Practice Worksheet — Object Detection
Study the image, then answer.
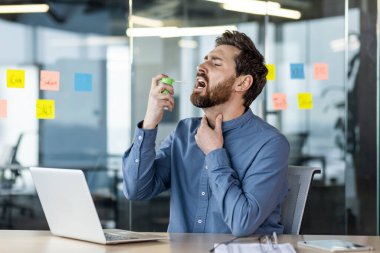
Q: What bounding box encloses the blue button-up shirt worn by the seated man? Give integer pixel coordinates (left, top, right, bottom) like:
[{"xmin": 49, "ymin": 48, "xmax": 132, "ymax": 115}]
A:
[{"xmin": 123, "ymin": 109, "xmax": 289, "ymax": 236}]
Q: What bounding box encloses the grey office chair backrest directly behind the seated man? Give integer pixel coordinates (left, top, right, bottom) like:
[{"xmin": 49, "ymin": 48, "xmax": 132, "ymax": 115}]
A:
[{"xmin": 281, "ymin": 165, "xmax": 321, "ymax": 235}]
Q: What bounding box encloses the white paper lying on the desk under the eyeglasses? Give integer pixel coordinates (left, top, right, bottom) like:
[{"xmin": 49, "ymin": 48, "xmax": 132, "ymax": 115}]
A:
[{"xmin": 215, "ymin": 243, "xmax": 296, "ymax": 253}]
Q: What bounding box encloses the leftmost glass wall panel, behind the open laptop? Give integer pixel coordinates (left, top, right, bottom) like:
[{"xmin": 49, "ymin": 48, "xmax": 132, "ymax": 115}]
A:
[{"xmin": 0, "ymin": 2, "xmax": 131, "ymax": 229}]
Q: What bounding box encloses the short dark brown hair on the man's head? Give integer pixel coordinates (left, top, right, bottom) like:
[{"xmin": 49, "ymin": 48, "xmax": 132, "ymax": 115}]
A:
[{"xmin": 215, "ymin": 31, "xmax": 268, "ymax": 107}]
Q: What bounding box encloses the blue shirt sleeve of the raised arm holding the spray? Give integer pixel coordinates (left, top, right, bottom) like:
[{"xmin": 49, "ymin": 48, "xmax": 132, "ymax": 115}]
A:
[{"xmin": 122, "ymin": 122, "xmax": 172, "ymax": 200}]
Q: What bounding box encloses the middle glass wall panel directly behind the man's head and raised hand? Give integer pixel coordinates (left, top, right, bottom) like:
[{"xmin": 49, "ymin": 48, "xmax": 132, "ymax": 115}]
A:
[{"xmin": 127, "ymin": 0, "xmax": 264, "ymax": 231}]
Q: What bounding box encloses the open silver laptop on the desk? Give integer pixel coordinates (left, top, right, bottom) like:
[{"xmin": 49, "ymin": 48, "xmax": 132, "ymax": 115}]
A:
[{"xmin": 30, "ymin": 167, "xmax": 167, "ymax": 244}]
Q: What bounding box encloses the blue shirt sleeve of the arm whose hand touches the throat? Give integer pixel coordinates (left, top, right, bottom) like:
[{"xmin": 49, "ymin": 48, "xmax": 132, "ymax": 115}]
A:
[{"xmin": 206, "ymin": 135, "xmax": 289, "ymax": 236}]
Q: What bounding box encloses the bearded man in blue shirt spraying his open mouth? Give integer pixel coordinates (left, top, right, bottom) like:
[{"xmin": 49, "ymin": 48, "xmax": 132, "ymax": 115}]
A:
[{"xmin": 123, "ymin": 31, "xmax": 289, "ymax": 236}]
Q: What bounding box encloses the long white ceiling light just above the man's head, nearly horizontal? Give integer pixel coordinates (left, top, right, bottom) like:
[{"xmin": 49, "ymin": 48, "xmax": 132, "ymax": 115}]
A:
[{"xmin": 127, "ymin": 25, "xmax": 237, "ymax": 38}]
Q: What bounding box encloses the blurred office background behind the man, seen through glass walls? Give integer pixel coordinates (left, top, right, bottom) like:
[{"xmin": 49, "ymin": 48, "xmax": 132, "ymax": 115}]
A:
[{"xmin": 0, "ymin": 0, "xmax": 380, "ymax": 235}]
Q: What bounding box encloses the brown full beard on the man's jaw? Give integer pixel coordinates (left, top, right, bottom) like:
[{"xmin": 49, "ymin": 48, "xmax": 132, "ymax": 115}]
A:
[{"xmin": 190, "ymin": 76, "xmax": 236, "ymax": 108}]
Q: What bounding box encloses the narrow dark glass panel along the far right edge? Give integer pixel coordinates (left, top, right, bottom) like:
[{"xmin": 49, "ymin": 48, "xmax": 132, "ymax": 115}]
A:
[{"xmin": 346, "ymin": 0, "xmax": 379, "ymax": 235}]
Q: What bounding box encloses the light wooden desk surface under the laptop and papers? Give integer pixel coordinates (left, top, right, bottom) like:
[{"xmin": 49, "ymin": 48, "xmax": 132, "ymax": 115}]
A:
[{"xmin": 0, "ymin": 230, "xmax": 380, "ymax": 253}]
